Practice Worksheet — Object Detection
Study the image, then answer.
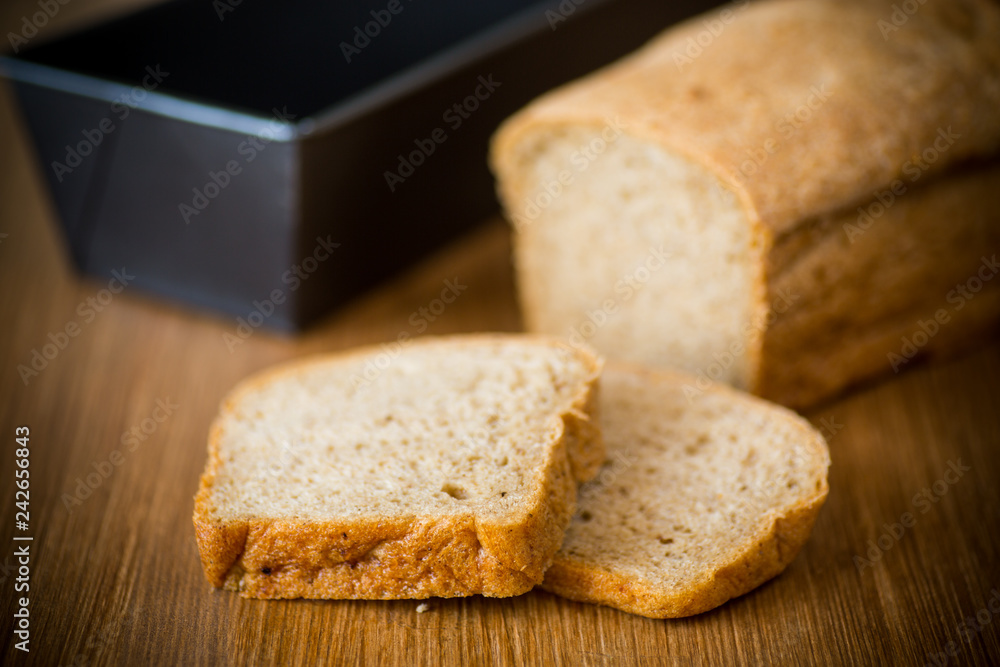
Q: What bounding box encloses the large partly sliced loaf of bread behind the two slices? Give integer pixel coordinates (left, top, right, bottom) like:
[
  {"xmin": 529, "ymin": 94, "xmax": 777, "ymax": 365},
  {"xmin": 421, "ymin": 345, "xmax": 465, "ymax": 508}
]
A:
[{"xmin": 491, "ymin": 0, "xmax": 1000, "ymax": 408}]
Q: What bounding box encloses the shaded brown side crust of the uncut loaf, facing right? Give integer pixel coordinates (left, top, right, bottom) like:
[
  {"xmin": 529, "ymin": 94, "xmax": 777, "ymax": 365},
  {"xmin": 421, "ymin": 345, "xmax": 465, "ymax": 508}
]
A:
[{"xmin": 753, "ymin": 161, "xmax": 1000, "ymax": 408}]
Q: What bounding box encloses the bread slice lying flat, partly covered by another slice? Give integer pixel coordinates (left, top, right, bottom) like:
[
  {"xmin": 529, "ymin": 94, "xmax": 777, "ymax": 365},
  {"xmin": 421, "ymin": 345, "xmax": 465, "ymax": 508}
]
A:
[{"xmin": 542, "ymin": 364, "xmax": 830, "ymax": 618}]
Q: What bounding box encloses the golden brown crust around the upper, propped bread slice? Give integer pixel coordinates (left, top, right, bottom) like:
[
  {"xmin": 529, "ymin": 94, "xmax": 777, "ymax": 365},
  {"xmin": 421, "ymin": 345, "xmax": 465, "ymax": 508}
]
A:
[{"xmin": 194, "ymin": 334, "xmax": 603, "ymax": 599}]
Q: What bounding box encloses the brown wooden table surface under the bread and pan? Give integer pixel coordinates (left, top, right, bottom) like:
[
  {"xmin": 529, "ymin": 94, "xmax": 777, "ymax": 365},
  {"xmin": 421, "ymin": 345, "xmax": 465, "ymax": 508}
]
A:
[{"xmin": 0, "ymin": 2, "xmax": 1000, "ymax": 665}]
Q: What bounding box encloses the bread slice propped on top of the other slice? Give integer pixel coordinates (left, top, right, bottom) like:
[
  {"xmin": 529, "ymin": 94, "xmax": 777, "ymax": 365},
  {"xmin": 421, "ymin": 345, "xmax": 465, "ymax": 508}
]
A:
[{"xmin": 194, "ymin": 335, "xmax": 603, "ymax": 599}]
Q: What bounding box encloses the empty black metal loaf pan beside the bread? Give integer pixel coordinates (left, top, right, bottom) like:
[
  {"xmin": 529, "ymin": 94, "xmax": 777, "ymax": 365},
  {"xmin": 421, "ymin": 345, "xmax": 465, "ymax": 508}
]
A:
[{"xmin": 0, "ymin": 0, "xmax": 715, "ymax": 330}]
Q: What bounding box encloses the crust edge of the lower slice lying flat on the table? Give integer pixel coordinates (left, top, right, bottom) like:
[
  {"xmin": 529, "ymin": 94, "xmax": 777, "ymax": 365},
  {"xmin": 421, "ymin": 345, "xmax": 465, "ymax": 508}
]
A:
[{"xmin": 541, "ymin": 363, "xmax": 830, "ymax": 618}]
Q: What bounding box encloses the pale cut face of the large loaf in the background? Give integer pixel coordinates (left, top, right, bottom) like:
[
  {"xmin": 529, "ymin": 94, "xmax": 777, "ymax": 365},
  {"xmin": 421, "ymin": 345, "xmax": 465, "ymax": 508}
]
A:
[{"xmin": 494, "ymin": 122, "xmax": 763, "ymax": 388}]
